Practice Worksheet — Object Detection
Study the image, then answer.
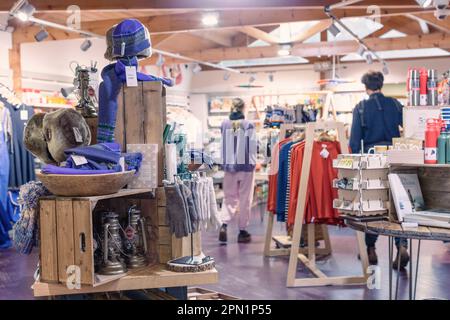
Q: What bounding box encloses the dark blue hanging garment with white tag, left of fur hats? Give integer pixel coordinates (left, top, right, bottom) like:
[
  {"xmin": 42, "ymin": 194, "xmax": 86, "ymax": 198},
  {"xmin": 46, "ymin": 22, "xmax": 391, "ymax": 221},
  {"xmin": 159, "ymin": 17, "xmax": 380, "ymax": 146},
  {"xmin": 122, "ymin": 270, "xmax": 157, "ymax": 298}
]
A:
[{"xmin": 0, "ymin": 99, "xmax": 36, "ymax": 188}]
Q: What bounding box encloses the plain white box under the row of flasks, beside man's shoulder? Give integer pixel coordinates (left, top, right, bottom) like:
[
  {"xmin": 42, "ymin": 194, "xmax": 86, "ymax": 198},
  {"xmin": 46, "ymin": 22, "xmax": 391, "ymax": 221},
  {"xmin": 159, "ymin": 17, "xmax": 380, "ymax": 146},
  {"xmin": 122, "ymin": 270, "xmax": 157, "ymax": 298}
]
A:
[{"xmin": 403, "ymin": 107, "xmax": 441, "ymax": 140}]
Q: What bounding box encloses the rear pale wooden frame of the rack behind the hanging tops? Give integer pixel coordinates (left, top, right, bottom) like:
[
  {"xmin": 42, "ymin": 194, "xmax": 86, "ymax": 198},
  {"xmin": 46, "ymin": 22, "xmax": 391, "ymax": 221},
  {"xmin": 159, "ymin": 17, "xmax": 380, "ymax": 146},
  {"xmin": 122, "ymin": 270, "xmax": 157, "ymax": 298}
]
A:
[{"xmin": 264, "ymin": 123, "xmax": 332, "ymax": 257}]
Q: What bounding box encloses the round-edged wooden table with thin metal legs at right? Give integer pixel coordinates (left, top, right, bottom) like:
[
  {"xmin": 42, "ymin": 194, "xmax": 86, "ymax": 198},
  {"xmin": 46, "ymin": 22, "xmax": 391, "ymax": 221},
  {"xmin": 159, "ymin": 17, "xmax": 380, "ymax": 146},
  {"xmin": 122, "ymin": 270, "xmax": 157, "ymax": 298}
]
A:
[{"xmin": 345, "ymin": 219, "xmax": 450, "ymax": 300}]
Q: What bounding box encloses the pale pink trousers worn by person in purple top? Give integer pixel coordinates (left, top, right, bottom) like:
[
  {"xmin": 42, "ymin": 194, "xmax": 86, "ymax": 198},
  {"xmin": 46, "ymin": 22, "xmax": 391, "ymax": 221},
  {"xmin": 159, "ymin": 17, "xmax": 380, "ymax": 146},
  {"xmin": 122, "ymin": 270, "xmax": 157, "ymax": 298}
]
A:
[{"xmin": 221, "ymin": 171, "xmax": 255, "ymax": 230}]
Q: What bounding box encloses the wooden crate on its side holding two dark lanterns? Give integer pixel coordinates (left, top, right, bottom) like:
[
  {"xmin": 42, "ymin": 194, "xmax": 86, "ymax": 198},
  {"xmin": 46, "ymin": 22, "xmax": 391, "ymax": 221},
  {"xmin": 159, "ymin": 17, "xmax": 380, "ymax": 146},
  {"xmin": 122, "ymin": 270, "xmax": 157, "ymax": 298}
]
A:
[{"xmin": 40, "ymin": 188, "xmax": 201, "ymax": 286}]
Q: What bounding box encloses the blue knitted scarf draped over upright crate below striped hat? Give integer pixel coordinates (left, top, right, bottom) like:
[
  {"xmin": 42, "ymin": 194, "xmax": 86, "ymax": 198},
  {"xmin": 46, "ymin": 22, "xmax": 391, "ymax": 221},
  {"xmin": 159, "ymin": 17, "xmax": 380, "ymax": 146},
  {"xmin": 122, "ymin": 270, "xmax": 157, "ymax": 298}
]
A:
[{"xmin": 97, "ymin": 57, "xmax": 173, "ymax": 143}]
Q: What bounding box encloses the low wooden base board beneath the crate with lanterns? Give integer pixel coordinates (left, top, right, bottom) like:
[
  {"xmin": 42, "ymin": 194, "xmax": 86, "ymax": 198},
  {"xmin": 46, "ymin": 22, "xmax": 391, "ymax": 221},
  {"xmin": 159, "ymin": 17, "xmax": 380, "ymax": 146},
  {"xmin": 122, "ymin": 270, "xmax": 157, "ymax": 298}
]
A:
[{"xmin": 32, "ymin": 264, "xmax": 219, "ymax": 297}]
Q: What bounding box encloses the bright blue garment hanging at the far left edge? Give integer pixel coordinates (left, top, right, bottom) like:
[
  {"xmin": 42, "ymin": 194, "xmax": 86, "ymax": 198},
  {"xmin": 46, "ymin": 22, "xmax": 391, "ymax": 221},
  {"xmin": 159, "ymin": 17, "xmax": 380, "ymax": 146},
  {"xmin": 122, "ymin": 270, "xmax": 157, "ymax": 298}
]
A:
[{"xmin": 0, "ymin": 107, "xmax": 12, "ymax": 248}]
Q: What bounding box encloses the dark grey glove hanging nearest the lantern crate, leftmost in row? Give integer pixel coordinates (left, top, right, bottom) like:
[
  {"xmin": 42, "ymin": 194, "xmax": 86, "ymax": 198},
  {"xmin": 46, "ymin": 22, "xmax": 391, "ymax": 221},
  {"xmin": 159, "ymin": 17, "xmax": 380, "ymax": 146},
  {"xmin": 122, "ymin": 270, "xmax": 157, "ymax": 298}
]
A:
[{"xmin": 164, "ymin": 184, "xmax": 189, "ymax": 238}]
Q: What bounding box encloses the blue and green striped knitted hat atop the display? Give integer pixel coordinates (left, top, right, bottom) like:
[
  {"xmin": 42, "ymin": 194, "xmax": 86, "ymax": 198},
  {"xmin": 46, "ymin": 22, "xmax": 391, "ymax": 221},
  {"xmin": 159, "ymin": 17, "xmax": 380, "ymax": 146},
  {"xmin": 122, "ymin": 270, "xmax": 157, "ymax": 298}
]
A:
[{"xmin": 112, "ymin": 19, "xmax": 152, "ymax": 59}]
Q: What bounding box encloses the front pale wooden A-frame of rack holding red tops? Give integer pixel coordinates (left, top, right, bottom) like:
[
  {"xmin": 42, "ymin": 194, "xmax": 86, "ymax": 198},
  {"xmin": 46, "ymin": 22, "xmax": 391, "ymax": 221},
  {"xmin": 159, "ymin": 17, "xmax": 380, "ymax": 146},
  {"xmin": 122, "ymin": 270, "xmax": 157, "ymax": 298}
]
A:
[{"xmin": 286, "ymin": 121, "xmax": 368, "ymax": 287}]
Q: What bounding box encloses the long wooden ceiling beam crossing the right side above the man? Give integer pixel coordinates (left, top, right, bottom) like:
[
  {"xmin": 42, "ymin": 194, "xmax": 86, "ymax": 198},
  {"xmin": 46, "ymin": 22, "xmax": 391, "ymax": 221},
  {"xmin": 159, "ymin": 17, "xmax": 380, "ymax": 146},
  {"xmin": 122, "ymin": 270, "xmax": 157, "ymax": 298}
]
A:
[{"xmin": 163, "ymin": 33, "xmax": 450, "ymax": 62}]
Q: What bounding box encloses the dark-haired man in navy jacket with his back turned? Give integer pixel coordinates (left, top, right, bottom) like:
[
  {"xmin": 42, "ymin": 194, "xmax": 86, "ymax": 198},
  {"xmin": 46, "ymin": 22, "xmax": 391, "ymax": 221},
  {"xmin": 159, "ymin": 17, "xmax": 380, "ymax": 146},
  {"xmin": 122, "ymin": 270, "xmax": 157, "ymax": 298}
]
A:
[{"xmin": 350, "ymin": 71, "xmax": 409, "ymax": 269}]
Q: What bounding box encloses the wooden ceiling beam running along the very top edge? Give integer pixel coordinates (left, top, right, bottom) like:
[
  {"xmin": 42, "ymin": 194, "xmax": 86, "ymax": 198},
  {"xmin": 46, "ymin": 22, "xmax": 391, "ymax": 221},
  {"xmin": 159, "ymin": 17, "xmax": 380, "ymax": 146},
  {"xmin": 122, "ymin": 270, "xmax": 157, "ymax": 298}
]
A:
[{"xmin": 0, "ymin": 0, "xmax": 417, "ymax": 11}]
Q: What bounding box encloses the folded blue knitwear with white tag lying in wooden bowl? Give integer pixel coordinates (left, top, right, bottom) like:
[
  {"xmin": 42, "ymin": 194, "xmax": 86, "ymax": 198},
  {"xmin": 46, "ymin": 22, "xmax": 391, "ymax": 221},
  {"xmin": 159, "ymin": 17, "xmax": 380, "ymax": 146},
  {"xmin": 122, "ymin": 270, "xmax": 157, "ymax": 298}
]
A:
[{"xmin": 42, "ymin": 142, "xmax": 142, "ymax": 174}]
